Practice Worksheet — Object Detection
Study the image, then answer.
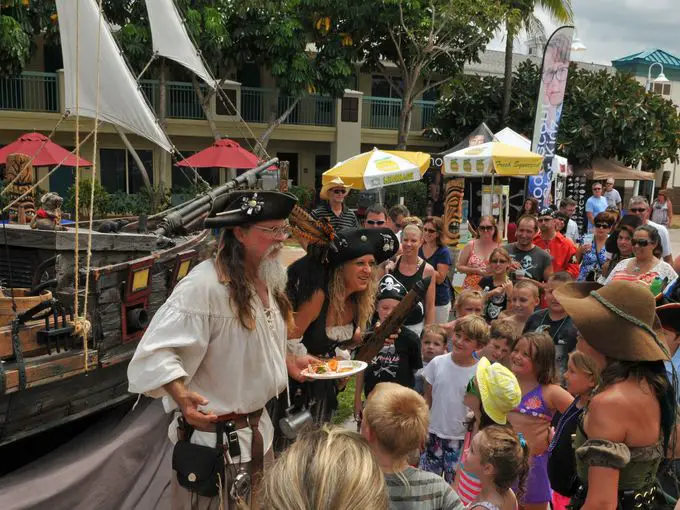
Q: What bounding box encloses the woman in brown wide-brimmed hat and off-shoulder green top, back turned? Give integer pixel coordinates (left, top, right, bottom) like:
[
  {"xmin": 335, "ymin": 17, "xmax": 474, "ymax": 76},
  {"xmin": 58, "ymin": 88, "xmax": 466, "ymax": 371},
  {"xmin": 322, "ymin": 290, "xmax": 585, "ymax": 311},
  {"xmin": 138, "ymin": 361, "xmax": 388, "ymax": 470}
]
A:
[{"xmin": 554, "ymin": 280, "xmax": 677, "ymax": 510}]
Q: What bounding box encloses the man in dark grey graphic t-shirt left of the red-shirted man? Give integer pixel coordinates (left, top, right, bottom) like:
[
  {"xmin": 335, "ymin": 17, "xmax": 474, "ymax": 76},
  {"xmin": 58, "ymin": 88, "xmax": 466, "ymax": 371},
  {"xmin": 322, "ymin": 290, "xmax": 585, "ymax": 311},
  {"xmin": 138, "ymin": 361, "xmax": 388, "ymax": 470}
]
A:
[{"xmin": 503, "ymin": 216, "xmax": 553, "ymax": 283}]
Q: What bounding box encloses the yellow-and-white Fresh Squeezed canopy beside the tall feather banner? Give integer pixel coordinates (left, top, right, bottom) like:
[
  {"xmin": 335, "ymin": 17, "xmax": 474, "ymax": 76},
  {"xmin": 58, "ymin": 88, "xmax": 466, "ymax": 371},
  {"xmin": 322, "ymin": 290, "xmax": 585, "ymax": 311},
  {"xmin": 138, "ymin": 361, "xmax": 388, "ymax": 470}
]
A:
[{"xmin": 442, "ymin": 142, "xmax": 543, "ymax": 177}]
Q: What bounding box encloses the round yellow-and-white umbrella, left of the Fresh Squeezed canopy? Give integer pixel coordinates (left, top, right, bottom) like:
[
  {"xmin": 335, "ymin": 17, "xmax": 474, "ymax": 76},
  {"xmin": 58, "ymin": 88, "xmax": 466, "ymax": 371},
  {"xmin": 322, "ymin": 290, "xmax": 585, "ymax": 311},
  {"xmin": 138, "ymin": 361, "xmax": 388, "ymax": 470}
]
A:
[{"xmin": 322, "ymin": 148, "xmax": 430, "ymax": 190}]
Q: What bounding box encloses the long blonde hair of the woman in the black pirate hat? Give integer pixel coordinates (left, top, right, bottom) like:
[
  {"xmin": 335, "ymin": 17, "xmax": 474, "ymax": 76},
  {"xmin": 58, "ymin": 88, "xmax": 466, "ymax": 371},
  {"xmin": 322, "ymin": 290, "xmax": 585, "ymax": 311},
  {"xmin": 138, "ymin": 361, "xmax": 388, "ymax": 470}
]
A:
[{"xmin": 328, "ymin": 260, "xmax": 378, "ymax": 331}]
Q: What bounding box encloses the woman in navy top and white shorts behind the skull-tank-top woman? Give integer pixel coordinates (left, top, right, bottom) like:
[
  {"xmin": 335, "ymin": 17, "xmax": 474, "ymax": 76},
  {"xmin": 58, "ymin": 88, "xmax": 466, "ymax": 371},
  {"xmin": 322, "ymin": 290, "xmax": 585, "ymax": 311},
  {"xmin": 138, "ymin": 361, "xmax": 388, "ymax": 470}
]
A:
[{"xmin": 418, "ymin": 216, "xmax": 451, "ymax": 324}]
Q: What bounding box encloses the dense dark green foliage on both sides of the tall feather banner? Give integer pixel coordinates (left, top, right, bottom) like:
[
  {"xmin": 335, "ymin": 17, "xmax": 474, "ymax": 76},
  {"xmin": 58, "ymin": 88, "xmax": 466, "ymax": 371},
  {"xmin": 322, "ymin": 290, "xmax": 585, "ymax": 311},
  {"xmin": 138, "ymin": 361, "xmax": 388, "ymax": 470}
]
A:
[{"xmin": 433, "ymin": 61, "xmax": 680, "ymax": 170}]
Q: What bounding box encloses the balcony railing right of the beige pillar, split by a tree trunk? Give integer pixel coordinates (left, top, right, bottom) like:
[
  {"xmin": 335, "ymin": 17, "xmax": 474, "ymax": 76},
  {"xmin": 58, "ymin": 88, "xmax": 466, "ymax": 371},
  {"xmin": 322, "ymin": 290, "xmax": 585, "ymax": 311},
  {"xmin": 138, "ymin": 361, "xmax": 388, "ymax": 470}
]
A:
[{"xmin": 361, "ymin": 96, "xmax": 437, "ymax": 131}]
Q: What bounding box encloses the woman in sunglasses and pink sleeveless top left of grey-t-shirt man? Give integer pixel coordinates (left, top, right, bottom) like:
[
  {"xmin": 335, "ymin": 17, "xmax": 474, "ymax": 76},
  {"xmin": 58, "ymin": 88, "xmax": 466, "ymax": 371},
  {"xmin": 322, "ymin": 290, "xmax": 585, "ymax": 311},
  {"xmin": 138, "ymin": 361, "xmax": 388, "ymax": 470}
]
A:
[{"xmin": 456, "ymin": 216, "xmax": 501, "ymax": 290}]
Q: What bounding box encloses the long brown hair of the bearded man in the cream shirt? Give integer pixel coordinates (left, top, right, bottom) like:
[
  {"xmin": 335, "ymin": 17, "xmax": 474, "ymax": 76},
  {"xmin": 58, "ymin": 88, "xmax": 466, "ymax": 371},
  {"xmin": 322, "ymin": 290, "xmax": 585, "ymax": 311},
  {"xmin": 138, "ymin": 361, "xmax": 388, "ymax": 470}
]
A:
[{"xmin": 215, "ymin": 229, "xmax": 293, "ymax": 331}]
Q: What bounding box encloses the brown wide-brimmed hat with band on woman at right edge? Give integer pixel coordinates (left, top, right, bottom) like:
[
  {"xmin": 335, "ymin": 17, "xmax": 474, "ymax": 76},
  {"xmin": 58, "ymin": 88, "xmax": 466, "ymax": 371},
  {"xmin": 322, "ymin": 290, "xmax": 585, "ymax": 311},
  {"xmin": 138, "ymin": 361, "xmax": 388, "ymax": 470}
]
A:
[{"xmin": 553, "ymin": 280, "xmax": 670, "ymax": 361}]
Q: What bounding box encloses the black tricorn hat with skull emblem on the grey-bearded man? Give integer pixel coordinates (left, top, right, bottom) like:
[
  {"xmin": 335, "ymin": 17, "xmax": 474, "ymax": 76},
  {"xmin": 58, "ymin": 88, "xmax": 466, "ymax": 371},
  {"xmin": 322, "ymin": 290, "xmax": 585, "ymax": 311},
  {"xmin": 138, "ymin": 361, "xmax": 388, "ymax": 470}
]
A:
[{"xmin": 204, "ymin": 191, "xmax": 297, "ymax": 228}]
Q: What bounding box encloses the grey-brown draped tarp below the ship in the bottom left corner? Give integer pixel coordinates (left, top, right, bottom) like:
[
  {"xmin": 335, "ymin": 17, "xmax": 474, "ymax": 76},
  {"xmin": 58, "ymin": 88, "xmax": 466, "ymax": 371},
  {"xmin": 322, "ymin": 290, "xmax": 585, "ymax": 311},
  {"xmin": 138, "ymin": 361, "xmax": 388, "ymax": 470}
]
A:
[{"xmin": 0, "ymin": 398, "xmax": 172, "ymax": 510}]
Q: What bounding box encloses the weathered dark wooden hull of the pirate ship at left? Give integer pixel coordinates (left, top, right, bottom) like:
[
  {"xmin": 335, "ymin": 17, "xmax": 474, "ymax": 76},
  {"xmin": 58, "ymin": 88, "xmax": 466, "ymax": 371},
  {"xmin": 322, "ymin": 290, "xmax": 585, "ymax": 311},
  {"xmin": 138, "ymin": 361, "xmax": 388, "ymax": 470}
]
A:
[{"xmin": 0, "ymin": 225, "xmax": 210, "ymax": 446}]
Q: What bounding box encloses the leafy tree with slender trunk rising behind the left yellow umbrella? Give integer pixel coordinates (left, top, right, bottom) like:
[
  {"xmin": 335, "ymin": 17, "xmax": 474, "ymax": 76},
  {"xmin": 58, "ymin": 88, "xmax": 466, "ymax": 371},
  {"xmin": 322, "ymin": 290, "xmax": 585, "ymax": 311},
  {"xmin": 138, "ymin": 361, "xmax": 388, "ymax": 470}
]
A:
[{"xmin": 310, "ymin": 0, "xmax": 502, "ymax": 148}]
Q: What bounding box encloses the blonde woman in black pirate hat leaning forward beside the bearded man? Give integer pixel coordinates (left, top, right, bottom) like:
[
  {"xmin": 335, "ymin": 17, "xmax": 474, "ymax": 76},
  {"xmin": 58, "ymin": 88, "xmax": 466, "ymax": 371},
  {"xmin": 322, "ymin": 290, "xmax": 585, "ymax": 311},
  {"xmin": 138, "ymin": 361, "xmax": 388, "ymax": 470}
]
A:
[{"xmin": 278, "ymin": 216, "xmax": 399, "ymax": 442}]
